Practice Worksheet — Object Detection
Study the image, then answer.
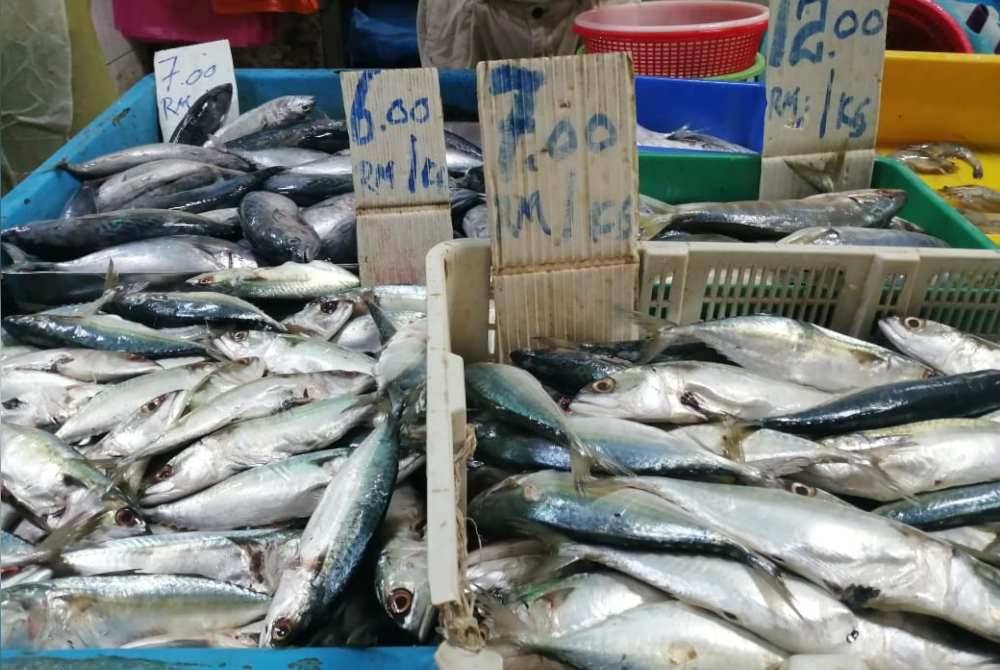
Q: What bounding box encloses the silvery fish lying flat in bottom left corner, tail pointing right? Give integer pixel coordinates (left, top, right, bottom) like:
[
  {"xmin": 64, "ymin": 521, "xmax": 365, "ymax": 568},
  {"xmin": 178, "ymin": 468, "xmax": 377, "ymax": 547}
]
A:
[{"xmin": 0, "ymin": 575, "xmax": 270, "ymax": 651}]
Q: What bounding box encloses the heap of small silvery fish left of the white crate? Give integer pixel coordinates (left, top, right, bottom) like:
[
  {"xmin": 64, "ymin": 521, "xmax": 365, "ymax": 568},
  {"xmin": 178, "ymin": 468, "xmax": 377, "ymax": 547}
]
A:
[{"xmin": 0, "ymin": 268, "xmax": 433, "ymax": 650}]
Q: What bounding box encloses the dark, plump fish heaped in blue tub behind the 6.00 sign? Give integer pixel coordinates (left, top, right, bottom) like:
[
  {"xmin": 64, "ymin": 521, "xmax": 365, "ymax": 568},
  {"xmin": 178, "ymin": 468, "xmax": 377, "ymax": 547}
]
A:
[{"xmin": 0, "ymin": 84, "xmax": 484, "ymax": 275}]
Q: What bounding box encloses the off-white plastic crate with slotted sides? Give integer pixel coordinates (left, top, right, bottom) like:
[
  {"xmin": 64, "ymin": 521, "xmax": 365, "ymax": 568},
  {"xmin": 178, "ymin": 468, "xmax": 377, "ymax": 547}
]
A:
[{"xmin": 427, "ymin": 240, "xmax": 1000, "ymax": 646}]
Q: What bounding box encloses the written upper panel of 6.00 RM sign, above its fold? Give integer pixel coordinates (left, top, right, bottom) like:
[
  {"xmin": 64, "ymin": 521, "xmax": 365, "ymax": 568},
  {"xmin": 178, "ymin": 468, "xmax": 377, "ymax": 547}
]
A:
[{"xmin": 341, "ymin": 69, "xmax": 448, "ymax": 206}]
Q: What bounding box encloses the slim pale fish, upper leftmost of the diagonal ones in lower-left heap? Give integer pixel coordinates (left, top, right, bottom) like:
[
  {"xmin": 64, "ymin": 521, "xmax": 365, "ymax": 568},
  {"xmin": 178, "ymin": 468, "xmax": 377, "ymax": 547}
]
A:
[{"xmin": 56, "ymin": 363, "xmax": 217, "ymax": 442}]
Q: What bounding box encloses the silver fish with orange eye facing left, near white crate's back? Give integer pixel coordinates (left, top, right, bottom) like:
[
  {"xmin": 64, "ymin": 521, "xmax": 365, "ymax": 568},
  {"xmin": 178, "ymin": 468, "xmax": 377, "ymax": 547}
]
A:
[{"xmin": 570, "ymin": 362, "xmax": 834, "ymax": 422}]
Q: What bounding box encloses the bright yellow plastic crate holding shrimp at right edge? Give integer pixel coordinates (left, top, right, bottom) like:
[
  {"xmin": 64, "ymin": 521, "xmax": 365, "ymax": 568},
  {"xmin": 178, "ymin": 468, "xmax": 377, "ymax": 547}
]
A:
[{"xmin": 878, "ymin": 51, "xmax": 1000, "ymax": 243}]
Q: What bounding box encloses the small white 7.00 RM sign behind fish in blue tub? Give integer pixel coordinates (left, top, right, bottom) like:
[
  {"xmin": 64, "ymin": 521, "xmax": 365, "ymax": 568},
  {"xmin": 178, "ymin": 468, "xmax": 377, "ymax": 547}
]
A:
[{"xmin": 153, "ymin": 40, "xmax": 240, "ymax": 141}]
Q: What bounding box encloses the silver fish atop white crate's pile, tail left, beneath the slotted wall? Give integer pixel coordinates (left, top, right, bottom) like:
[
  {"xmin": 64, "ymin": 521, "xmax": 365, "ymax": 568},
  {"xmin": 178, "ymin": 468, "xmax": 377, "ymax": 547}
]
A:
[{"xmin": 641, "ymin": 315, "xmax": 934, "ymax": 393}]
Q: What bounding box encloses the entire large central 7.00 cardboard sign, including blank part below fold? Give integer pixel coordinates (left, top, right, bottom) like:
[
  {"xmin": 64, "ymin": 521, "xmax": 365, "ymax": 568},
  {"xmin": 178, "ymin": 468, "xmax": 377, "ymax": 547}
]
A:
[{"xmin": 478, "ymin": 54, "xmax": 638, "ymax": 359}]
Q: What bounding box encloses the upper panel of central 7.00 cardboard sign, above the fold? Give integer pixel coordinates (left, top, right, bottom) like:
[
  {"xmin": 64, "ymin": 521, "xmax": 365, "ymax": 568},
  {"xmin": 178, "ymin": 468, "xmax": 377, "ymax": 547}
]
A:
[{"xmin": 479, "ymin": 56, "xmax": 636, "ymax": 267}]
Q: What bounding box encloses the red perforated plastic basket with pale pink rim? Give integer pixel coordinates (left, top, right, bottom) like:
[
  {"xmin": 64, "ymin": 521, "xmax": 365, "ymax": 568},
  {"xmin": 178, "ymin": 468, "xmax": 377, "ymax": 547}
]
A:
[{"xmin": 573, "ymin": 0, "xmax": 769, "ymax": 78}]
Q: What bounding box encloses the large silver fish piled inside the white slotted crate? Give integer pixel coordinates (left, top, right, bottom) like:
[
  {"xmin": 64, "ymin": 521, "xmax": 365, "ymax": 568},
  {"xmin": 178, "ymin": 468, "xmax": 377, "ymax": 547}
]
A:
[{"xmin": 458, "ymin": 315, "xmax": 1000, "ymax": 670}]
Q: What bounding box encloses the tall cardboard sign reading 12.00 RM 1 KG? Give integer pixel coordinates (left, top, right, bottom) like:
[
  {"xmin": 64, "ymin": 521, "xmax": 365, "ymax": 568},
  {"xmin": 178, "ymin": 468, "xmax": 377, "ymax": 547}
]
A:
[{"xmin": 760, "ymin": 0, "xmax": 889, "ymax": 198}]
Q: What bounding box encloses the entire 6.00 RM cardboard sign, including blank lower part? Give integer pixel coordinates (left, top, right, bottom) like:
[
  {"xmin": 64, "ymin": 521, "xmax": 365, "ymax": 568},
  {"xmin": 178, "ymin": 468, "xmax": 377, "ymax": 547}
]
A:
[{"xmin": 340, "ymin": 68, "xmax": 452, "ymax": 286}]
